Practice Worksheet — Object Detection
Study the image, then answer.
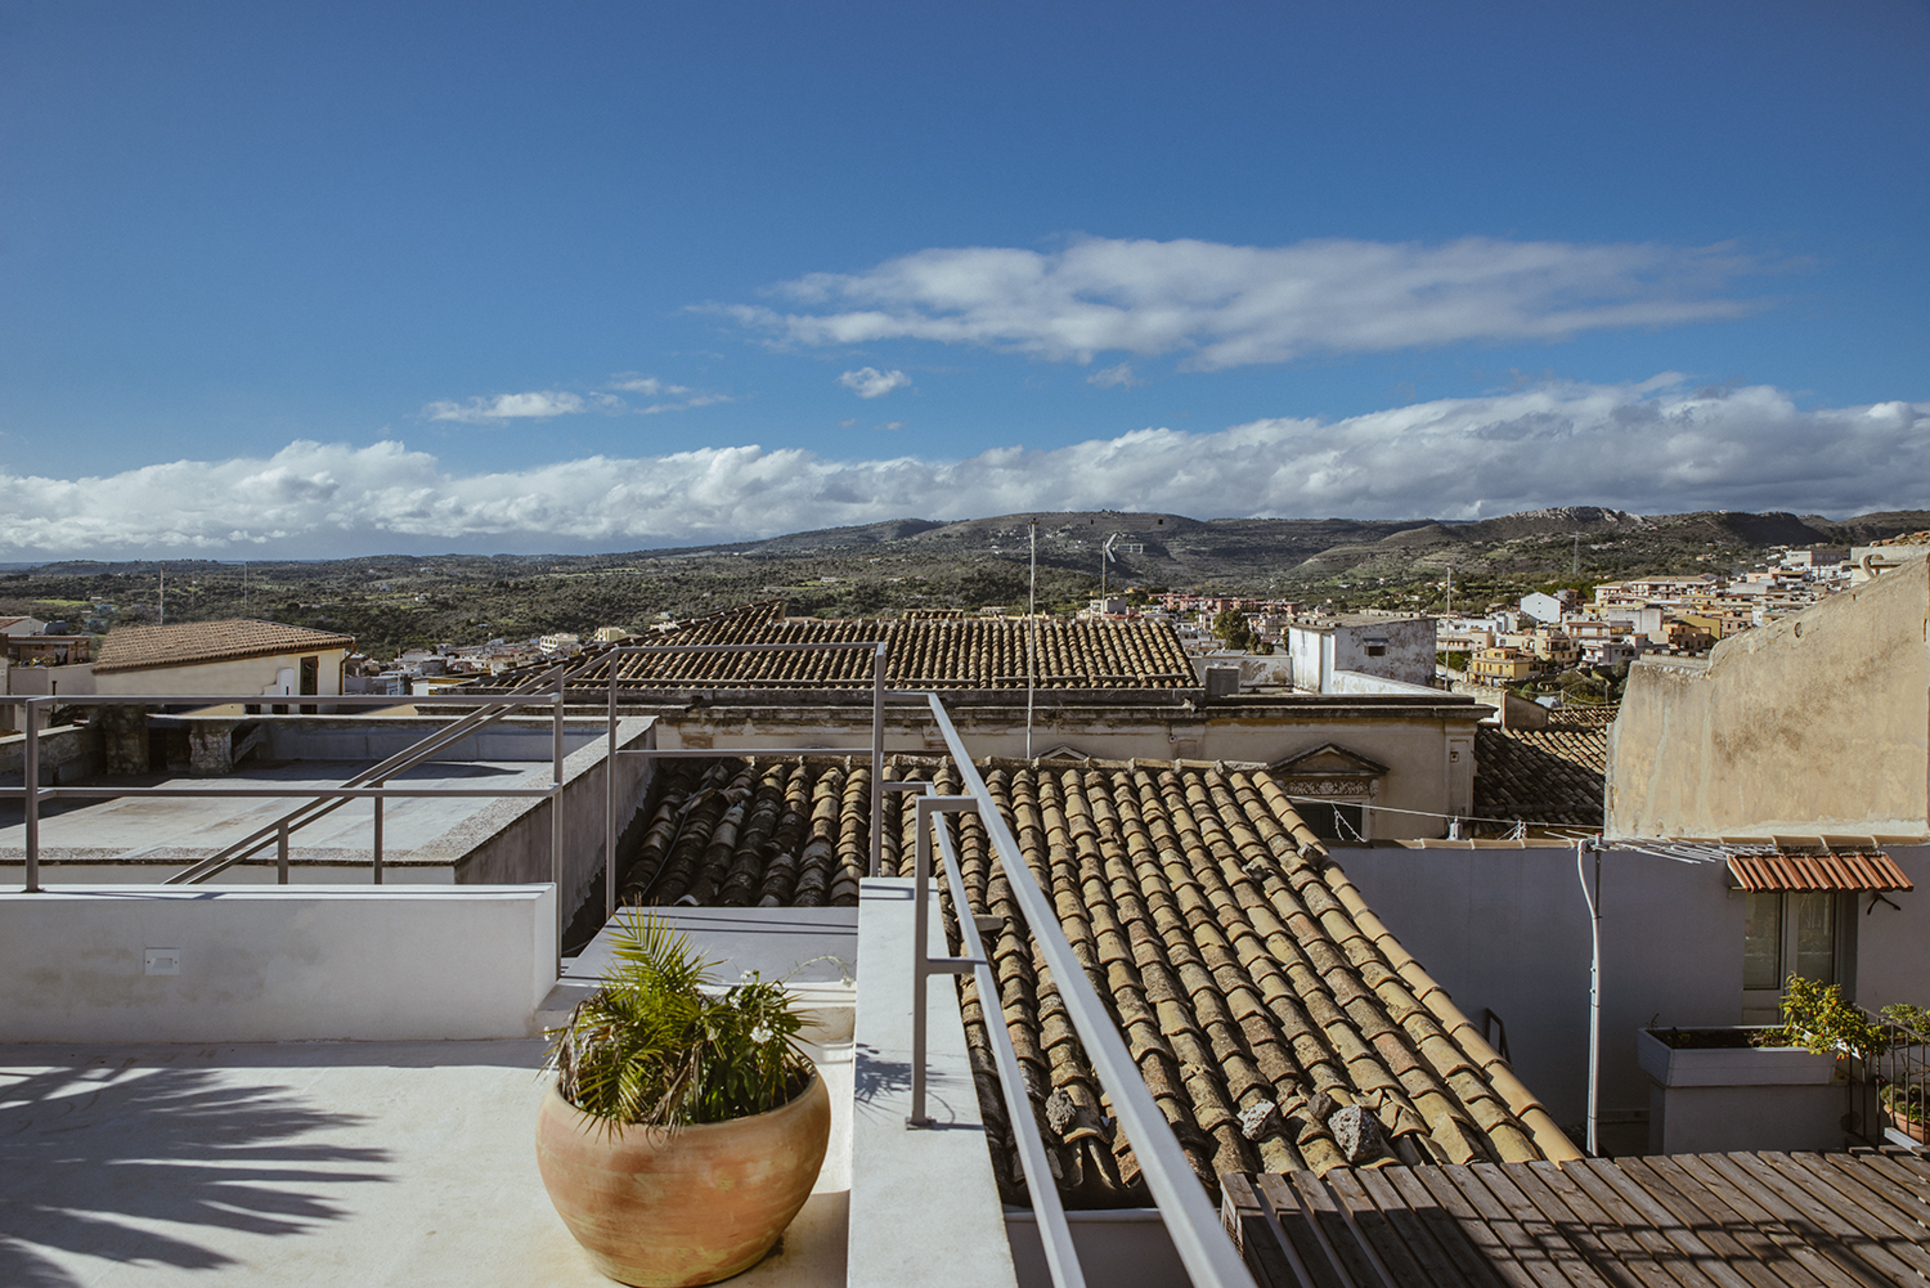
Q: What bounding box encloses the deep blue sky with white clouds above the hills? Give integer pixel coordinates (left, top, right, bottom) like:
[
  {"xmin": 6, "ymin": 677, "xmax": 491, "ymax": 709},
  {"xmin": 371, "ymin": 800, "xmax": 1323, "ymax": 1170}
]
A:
[{"xmin": 0, "ymin": 0, "xmax": 1930, "ymax": 558}]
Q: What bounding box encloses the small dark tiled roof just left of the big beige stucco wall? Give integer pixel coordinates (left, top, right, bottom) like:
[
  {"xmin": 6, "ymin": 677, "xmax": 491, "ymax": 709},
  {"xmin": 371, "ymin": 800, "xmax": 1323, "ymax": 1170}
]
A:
[{"xmin": 1475, "ymin": 709, "xmax": 1613, "ymax": 830}]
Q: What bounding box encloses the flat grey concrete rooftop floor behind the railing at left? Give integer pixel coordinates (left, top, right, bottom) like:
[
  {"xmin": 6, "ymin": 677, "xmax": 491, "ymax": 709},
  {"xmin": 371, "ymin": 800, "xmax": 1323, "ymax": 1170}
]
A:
[{"xmin": 0, "ymin": 761, "xmax": 550, "ymax": 865}]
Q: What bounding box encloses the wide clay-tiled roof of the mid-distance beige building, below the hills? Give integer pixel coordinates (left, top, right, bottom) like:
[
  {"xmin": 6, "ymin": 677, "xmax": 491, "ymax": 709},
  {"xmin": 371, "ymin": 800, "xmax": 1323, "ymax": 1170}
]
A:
[{"xmin": 470, "ymin": 601, "xmax": 1199, "ymax": 691}]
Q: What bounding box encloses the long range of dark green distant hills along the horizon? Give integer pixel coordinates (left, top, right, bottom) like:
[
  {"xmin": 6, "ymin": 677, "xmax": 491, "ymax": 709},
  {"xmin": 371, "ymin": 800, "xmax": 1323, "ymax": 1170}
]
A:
[{"xmin": 0, "ymin": 506, "xmax": 1930, "ymax": 657}]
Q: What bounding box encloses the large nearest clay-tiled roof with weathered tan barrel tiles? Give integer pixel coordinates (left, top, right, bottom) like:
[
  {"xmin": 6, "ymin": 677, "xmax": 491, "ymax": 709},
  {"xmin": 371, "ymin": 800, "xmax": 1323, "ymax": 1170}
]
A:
[{"xmin": 621, "ymin": 757, "xmax": 1573, "ymax": 1207}]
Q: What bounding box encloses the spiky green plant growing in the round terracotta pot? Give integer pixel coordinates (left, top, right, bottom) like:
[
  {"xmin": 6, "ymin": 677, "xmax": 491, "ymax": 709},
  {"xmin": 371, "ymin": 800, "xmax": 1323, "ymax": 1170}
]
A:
[{"xmin": 546, "ymin": 908, "xmax": 811, "ymax": 1132}]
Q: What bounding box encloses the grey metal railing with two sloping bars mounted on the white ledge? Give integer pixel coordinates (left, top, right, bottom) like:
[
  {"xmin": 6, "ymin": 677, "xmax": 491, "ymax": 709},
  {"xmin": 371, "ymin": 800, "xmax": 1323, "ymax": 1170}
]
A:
[{"xmin": 910, "ymin": 693, "xmax": 1253, "ymax": 1288}]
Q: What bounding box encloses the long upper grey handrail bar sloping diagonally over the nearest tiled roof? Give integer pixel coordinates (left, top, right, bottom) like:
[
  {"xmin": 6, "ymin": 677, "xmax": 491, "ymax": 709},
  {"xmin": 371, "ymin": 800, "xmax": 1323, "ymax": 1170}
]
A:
[{"xmin": 911, "ymin": 693, "xmax": 1255, "ymax": 1288}]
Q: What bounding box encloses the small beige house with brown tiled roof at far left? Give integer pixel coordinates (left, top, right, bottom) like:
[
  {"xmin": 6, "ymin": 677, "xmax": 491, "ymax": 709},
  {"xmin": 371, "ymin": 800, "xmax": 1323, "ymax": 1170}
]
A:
[{"xmin": 95, "ymin": 618, "xmax": 355, "ymax": 697}]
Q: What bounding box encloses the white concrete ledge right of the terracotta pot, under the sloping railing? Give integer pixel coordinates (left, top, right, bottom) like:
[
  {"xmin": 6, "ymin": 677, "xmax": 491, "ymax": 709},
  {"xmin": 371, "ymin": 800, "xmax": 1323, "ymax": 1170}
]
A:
[{"xmin": 845, "ymin": 879, "xmax": 1019, "ymax": 1288}]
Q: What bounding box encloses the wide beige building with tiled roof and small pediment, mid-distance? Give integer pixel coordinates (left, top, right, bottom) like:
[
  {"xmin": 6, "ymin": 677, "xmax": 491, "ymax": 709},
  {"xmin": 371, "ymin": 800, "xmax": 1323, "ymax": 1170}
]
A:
[{"xmin": 465, "ymin": 601, "xmax": 1490, "ymax": 840}]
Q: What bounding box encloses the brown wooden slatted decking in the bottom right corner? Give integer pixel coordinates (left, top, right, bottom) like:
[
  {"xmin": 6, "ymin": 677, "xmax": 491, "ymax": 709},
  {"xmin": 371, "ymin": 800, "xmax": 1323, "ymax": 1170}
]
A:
[{"xmin": 1222, "ymin": 1151, "xmax": 1930, "ymax": 1288}]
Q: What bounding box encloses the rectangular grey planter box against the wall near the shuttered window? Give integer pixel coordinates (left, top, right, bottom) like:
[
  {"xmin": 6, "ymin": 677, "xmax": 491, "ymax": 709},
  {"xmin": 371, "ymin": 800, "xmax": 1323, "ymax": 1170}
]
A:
[{"xmin": 1635, "ymin": 1027, "xmax": 1849, "ymax": 1155}]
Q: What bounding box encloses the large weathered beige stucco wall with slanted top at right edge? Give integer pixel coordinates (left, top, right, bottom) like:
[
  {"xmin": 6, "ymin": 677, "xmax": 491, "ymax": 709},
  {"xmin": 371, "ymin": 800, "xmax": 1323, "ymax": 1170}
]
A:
[{"xmin": 1608, "ymin": 560, "xmax": 1930, "ymax": 838}]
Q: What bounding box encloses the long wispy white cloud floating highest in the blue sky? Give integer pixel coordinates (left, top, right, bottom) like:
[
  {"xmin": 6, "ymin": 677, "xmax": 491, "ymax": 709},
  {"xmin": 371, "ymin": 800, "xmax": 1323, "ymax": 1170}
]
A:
[{"xmin": 720, "ymin": 238, "xmax": 1760, "ymax": 371}]
